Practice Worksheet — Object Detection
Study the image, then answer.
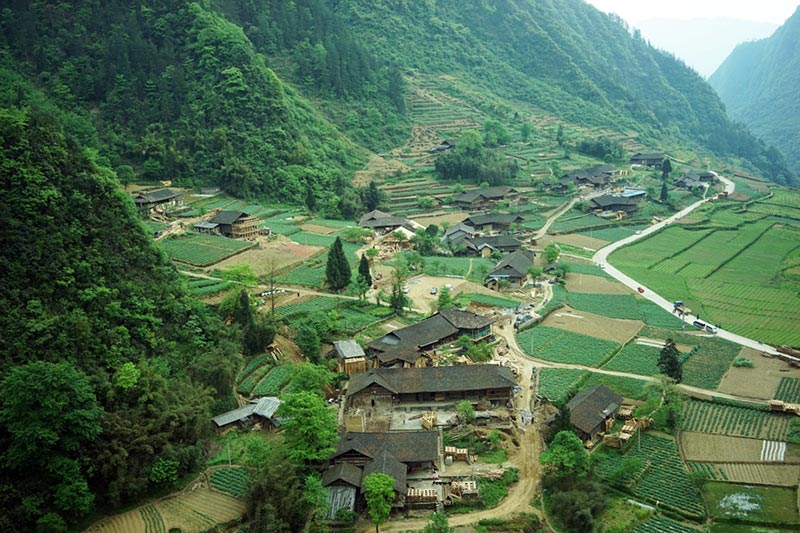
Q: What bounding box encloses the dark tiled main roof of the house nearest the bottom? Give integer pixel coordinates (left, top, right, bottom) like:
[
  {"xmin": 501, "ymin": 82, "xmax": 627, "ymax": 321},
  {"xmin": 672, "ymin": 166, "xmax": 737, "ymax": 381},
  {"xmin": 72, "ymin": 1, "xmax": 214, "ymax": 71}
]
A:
[{"xmin": 333, "ymin": 431, "xmax": 439, "ymax": 463}]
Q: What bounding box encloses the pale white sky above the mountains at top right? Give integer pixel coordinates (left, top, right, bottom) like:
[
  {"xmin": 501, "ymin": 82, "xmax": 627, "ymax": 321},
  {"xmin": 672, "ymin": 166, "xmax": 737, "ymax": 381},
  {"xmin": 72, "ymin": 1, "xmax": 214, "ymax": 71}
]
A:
[{"xmin": 586, "ymin": 0, "xmax": 800, "ymax": 25}]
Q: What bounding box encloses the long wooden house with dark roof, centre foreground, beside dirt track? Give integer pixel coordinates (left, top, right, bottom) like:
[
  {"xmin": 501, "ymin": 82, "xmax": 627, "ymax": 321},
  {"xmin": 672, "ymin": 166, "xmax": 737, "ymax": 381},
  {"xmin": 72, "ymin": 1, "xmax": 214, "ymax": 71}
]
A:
[{"xmin": 345, "ymin": 365, "xmax": 516, "ymax": 408}]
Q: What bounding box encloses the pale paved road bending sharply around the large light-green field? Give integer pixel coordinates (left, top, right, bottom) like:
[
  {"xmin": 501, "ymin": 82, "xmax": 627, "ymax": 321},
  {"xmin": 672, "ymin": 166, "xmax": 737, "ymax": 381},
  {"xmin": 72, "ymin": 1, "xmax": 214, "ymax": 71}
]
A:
[{"xmin": 592, "ymin": 176, "xmax": 779, "ymax": 355}]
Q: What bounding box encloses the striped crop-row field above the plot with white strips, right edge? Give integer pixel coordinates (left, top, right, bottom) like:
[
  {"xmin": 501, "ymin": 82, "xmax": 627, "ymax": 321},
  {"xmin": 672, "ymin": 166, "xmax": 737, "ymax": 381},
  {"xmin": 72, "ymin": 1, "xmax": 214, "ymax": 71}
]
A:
[{"xmin": 679, "ymin": 400, "xmax": 792, "ymax": 441}]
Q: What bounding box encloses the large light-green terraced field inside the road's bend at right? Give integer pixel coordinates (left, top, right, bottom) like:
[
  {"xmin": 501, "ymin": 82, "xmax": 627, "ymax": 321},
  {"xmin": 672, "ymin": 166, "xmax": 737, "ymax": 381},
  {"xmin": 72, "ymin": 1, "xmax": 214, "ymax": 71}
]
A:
[{"xmin": 609, "ymin": 197, "xmax": 800, "ymax": 345}]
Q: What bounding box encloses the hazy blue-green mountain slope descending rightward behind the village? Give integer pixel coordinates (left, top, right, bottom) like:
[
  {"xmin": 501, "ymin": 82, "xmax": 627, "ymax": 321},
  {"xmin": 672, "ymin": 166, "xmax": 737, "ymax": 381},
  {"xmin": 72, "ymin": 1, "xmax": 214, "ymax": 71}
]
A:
[{"xmin": 335, "ymin": 0, "xmax": 793, "ymax": 183}]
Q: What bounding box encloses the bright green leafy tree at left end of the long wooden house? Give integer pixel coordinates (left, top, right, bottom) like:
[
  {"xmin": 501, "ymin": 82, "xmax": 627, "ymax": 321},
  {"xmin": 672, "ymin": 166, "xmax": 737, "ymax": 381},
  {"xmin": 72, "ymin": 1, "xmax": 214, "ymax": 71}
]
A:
[{"xmin": 278, "ymin": 391, "xmax": 339, "ymax": 465}]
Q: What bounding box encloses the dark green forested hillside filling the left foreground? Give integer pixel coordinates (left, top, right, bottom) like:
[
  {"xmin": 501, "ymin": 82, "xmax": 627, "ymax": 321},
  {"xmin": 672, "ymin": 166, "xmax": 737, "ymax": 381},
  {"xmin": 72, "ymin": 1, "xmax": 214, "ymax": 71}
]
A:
[{"xmin": 0, "ymin": 70, "xmax": 241, "ymax": 531}]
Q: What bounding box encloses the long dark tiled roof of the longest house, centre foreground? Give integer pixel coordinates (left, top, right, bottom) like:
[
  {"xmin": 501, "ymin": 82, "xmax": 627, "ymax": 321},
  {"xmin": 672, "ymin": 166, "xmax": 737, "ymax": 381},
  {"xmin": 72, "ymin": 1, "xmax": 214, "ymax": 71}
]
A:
[{"xmin": 347, "ymin": 365, "xmax": 516, "ymax": 396}]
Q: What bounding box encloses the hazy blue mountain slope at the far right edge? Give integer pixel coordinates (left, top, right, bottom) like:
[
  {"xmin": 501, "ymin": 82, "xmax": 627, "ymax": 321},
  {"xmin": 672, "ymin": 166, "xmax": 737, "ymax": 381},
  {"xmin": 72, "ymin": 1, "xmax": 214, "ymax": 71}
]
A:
[{"xmin": 708, "ymin": 8, "xmax": 800, "ymax": 178}]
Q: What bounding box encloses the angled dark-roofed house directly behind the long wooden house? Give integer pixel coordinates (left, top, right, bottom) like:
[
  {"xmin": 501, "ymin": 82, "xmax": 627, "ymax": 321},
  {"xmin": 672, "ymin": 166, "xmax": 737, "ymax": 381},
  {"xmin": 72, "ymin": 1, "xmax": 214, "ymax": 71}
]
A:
[{"xmin": 367, "ymin": 307, "xmax": 495, "ymax": 367}]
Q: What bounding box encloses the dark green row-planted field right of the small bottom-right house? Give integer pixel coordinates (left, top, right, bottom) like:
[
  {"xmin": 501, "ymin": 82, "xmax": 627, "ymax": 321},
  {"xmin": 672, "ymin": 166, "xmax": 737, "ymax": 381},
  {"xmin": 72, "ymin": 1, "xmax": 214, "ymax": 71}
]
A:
[{"xmin": 597, "ymin": 433, "xmax": 706, "ymax": 518}]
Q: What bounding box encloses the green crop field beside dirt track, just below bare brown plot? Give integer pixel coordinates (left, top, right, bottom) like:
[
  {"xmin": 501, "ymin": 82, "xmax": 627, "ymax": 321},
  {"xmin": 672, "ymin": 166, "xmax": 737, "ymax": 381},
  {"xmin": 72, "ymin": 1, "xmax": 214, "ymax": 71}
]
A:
[{"xmin": 517, "ymin": 326, "xmax": 619, "ymax": 366}]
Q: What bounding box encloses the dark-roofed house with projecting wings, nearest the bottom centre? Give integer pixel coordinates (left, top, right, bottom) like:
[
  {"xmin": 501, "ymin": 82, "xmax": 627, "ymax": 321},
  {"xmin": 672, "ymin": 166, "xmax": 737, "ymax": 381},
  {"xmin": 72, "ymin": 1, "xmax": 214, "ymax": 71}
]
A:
[{"xmin": 322, "ymin": 431, "xmax": 443, "ymax": 520}]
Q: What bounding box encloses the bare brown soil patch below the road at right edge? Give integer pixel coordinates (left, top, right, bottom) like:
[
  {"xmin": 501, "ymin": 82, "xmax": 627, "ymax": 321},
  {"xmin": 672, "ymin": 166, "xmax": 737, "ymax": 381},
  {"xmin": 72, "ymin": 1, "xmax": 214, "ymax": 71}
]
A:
[{"xmin": 719, "ymin": 348, "xmax": 800, "ymax": 400}]
